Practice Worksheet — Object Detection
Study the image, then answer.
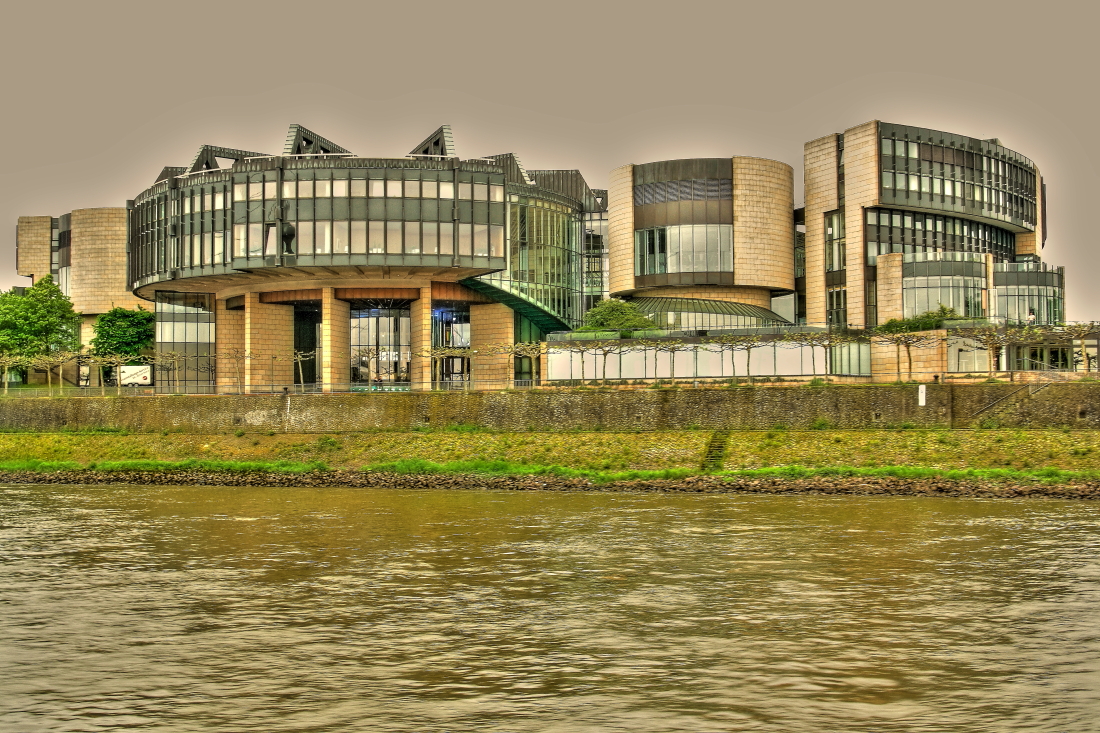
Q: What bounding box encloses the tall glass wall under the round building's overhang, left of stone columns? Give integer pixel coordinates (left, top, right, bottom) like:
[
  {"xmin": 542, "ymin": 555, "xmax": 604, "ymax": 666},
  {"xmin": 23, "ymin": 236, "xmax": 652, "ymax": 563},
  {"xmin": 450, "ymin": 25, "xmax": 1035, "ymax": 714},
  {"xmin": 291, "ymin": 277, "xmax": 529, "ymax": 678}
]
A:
[{"xmin": 154, "ymin": 291, "xmax": 216, "ymax": 393}]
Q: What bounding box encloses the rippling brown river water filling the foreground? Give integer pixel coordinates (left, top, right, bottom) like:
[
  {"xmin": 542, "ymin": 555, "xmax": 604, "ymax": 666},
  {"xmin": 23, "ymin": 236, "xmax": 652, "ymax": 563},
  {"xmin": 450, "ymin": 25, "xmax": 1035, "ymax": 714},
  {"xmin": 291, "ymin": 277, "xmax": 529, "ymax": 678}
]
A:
[{"xmin": 0, "ymin": 485, "xmax": 1100, "ymax": 733}]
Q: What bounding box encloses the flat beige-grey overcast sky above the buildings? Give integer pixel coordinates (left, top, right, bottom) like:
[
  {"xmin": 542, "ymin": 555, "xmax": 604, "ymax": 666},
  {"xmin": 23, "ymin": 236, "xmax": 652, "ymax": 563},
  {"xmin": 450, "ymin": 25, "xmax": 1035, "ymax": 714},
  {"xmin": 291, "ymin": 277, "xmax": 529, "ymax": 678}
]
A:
[{"xmin": 0, "ymin": 0, "xmax": 1100, "ymax": 320}]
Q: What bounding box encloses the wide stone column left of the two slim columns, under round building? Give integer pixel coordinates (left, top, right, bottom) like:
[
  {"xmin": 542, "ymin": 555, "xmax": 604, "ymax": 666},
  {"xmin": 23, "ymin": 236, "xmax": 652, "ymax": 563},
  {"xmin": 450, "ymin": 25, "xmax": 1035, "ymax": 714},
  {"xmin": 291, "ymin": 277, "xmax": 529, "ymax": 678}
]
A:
[{"xmin": 244, "ymin": 293, "xmax": 294, "ymax": 392}]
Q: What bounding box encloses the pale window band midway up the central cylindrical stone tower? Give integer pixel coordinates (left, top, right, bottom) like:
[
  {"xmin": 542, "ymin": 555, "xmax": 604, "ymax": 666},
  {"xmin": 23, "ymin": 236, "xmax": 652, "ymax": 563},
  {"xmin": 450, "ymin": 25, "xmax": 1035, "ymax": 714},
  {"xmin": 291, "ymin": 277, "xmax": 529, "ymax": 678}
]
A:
[{"xmin": 634, "ymin": 225, "xmax": 734, "ymax": 275}]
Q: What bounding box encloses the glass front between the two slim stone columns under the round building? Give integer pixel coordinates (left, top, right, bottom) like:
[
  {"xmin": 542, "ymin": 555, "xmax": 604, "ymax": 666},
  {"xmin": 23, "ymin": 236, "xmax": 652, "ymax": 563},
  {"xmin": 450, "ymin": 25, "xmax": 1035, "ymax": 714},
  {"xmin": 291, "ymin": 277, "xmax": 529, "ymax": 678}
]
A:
[{"xmin": 351, "ymin": 299, "xmax": 413, "ymax": 387}]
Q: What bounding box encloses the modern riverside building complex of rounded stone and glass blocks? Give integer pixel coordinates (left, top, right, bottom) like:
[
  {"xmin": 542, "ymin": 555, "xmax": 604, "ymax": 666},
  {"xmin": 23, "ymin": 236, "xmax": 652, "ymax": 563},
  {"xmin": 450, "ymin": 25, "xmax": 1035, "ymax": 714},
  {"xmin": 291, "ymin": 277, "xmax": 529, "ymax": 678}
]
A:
[{"xmin": 17, "ymin": 121, "xmax": 1064, "ymax": 389}]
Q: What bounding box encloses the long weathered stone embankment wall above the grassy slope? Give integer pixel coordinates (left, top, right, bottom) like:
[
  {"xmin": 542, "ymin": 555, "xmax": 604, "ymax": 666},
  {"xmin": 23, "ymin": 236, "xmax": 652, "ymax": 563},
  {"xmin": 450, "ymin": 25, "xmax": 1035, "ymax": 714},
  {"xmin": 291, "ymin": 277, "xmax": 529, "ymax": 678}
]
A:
[{"xmin": 0, "ymin": 383, "xmax": 1100, "ymax": 433}]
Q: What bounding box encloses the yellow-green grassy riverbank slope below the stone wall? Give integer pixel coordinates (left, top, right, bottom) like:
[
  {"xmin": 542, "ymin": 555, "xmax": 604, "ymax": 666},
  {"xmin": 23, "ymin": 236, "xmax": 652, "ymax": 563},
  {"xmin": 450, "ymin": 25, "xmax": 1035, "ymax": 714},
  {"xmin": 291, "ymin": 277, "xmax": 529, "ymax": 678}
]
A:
[{"xmin": 0, "ymin": 429, "xmax": 1100, "ymax": 478}]
